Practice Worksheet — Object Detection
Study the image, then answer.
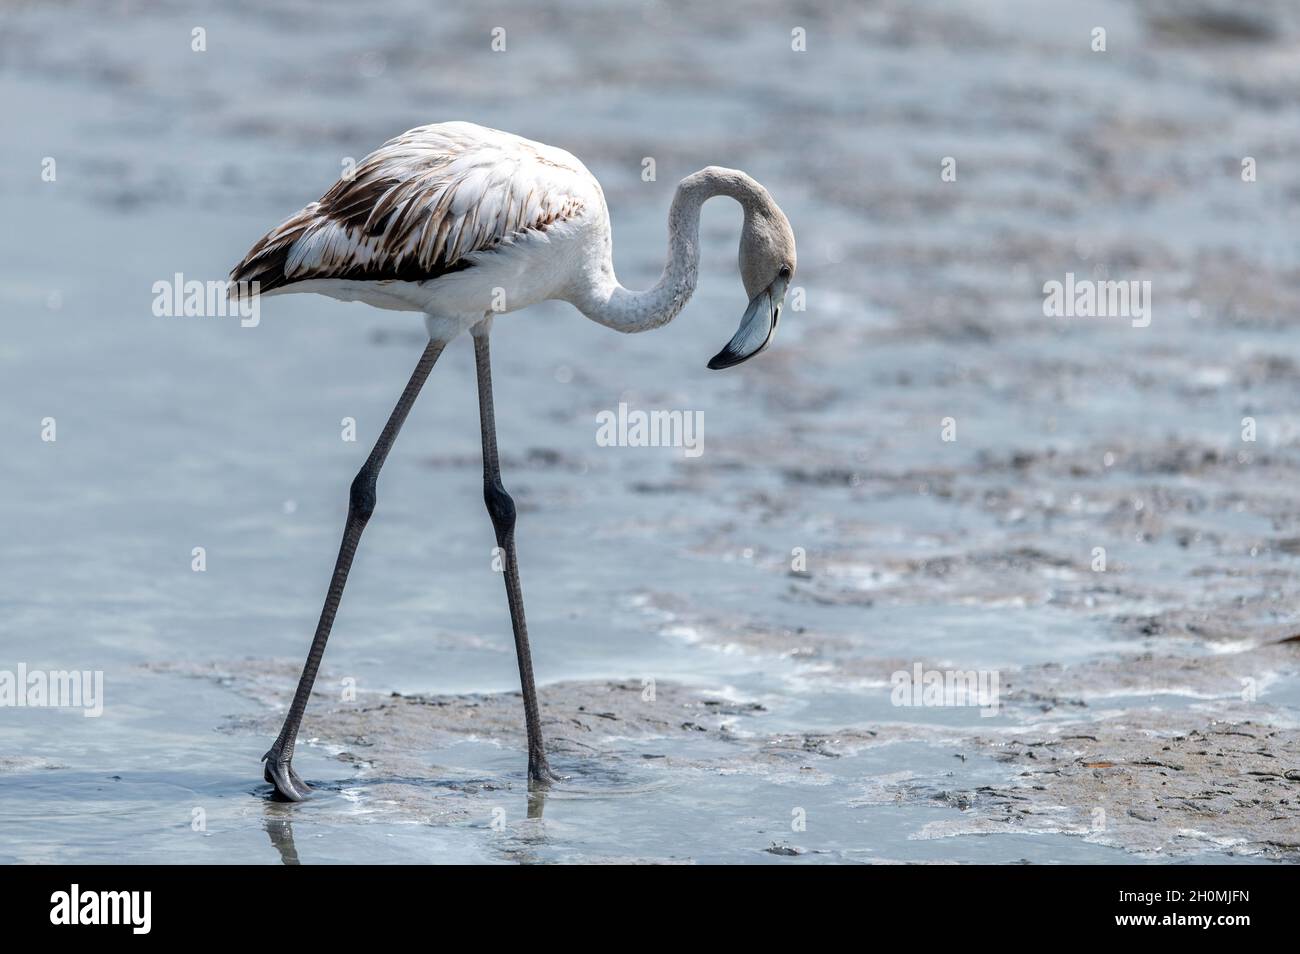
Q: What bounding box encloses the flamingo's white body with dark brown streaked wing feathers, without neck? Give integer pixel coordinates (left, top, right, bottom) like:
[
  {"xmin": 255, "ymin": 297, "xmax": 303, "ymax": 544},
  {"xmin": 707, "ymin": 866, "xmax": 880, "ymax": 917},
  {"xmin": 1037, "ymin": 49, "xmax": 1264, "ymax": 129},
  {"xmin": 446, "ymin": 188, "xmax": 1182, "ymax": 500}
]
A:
[{"xmin": 231, "ymin": 122, "xmax": 608, "ymax": 324}]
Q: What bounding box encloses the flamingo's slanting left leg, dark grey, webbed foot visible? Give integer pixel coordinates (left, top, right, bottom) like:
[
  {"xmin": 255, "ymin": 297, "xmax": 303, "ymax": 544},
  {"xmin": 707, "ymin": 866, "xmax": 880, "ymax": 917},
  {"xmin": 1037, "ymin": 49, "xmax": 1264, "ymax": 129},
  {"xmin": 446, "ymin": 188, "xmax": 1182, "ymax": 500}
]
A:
[{"xmin": 261, "ymin": 341, "xmax": 446, "ymax": 802}]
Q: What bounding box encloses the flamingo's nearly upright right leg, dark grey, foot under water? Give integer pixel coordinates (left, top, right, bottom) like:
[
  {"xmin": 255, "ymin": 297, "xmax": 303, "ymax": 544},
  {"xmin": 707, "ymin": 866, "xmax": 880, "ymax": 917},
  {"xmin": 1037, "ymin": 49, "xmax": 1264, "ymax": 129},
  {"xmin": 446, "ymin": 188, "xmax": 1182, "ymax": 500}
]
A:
[{"xmin": 473, "ymin": 330, "xmax": 559, "ymax": 785}]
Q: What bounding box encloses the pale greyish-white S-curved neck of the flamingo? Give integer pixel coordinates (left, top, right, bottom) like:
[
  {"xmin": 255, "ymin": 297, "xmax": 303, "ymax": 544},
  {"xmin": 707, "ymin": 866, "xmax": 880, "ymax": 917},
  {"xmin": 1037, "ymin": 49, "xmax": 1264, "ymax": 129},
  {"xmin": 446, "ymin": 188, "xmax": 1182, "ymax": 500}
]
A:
[{"xmin": 571, "ymin": 165, "xmax": 767, "ymax": 333}]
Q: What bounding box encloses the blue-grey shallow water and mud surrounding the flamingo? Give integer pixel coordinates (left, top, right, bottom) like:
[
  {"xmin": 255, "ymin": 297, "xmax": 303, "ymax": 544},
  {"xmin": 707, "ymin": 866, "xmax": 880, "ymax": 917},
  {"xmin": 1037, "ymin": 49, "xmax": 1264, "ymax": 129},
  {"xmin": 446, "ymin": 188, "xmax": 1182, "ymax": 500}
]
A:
[{"xmin": 0, "ymin": 0, "xmax": 1300, "ymax": 863}]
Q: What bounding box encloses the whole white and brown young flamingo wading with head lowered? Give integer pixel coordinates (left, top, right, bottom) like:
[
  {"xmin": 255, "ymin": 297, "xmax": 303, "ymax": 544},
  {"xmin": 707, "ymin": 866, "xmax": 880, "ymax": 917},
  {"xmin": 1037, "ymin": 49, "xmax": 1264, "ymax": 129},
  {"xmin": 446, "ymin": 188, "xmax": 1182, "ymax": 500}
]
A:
[{"xmin": 230, "ymin": 122, "xmax": 796, "ymax": 802}]
